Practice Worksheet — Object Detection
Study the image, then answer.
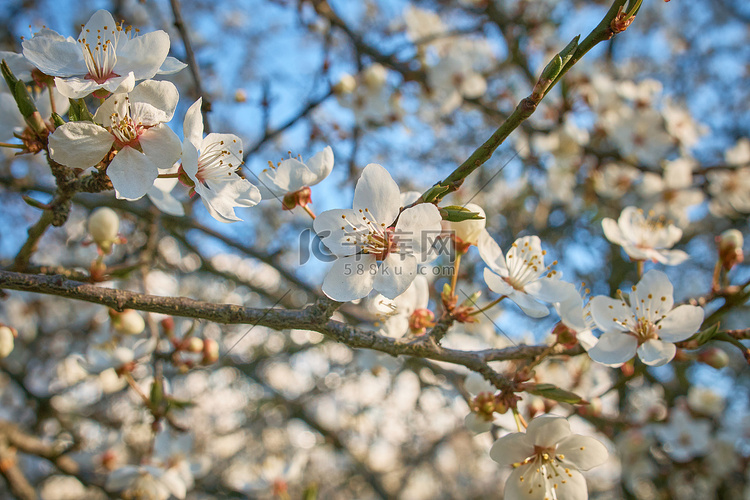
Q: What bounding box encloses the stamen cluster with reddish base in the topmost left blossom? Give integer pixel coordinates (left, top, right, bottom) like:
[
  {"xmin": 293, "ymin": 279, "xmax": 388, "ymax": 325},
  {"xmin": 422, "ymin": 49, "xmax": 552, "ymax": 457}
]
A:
[{"xmin": 78, "ymin": 24, "xmax": 130, "ymax": 84}]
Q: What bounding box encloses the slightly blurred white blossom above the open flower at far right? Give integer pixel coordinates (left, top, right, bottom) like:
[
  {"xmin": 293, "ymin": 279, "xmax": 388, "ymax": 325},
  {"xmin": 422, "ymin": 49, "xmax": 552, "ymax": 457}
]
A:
[{"xmin": 602, "ymin": 207, "xmax": 688, "ymax": 266}]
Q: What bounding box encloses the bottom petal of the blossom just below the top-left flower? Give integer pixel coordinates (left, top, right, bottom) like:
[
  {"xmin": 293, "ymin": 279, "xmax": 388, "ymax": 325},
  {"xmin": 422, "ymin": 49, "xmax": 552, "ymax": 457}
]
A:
[{"xmin": 107, "ymin": 146, "xmax": 159, "ymax": 200}]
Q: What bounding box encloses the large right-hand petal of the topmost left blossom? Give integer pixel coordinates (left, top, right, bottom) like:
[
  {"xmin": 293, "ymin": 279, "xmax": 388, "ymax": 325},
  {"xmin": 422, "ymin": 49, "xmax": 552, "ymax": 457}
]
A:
[{"xmin": 115, "ymin": 30, "xmax": 169, "ymax": 80}]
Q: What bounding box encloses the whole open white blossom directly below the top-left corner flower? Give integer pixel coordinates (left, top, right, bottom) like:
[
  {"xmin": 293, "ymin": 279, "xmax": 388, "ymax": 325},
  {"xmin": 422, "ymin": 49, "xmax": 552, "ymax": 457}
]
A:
[{"xmin": 49, "ymin": 80, "xmax": 181, "ymax": 200}]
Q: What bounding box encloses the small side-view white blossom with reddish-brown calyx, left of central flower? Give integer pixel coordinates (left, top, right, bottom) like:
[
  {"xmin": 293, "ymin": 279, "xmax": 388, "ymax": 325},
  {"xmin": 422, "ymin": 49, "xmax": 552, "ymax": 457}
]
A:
[{"xmin": 258, "ymin": 146, "xmax": 333, "ymax": 210}]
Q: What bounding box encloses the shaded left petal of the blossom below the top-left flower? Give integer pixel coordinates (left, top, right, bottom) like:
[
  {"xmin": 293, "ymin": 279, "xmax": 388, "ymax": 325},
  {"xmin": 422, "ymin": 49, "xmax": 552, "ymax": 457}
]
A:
[{"xmin": 49, "ymin": 122, "xmax": 114, "ymax": 169}]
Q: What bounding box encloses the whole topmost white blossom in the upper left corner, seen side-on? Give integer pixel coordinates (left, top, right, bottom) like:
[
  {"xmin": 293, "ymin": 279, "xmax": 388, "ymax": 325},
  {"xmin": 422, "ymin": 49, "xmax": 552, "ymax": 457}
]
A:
[{"xmin": 22, "ymin": 10, "xmax": 186, "ymax": 99}]
